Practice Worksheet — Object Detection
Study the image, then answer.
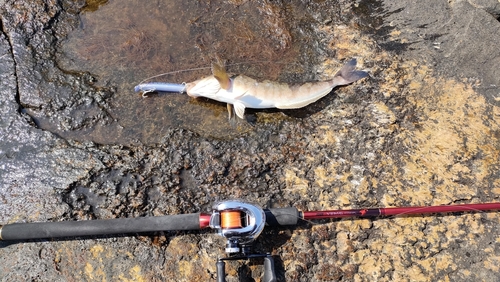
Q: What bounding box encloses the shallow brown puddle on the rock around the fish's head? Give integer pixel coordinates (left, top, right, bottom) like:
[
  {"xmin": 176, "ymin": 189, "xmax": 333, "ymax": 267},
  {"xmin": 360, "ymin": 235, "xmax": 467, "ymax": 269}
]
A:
[{"xmin": 57, "ymin": 0, "xmax": 315, "ymax": 143}]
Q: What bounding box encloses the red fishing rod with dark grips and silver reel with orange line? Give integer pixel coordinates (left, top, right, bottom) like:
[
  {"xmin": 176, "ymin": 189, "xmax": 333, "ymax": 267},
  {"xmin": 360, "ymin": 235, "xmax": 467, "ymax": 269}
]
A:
[{"xmin": 0, "ymin": 200, "xmax": 500, "ymax": 282}]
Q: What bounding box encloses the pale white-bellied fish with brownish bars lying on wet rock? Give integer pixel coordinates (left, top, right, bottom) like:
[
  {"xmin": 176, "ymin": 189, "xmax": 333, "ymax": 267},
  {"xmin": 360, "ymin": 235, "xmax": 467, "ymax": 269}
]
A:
[{"xmin": 184, "ymin": 59, "xmax": 368, "ymax": 119}]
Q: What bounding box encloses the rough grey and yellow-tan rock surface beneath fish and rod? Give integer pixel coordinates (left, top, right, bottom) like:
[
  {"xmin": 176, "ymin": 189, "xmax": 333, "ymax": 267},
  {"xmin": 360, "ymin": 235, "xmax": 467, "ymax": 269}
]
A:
[{"xmin": 0, "ymin": 0, "xmax": 500, "ymax": 281}]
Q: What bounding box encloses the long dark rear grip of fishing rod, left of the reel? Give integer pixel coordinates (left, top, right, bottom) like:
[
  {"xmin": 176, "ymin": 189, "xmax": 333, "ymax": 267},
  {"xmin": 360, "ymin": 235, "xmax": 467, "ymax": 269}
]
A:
[{"xmin": 0, "ymin": 213, "xmax": 200, "ymax": 240}]
